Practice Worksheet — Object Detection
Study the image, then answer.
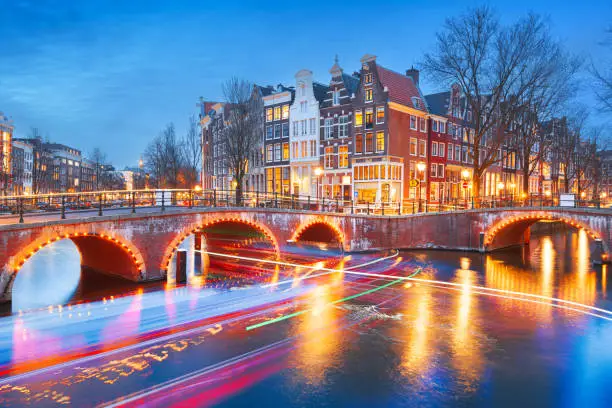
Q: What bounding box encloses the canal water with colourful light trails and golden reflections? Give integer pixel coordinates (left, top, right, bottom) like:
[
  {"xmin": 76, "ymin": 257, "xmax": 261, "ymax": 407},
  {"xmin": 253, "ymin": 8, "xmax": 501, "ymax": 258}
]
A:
[{"xmin": 0, "ymin": 228, "xmax": 612, "ymax": 407}]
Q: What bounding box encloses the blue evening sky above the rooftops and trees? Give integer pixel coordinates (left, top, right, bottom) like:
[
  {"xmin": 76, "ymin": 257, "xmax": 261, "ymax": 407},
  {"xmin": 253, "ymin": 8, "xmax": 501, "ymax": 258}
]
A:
[{"xmin": 0, "ymin": 0, "xmax": 612, "ymax": 167}]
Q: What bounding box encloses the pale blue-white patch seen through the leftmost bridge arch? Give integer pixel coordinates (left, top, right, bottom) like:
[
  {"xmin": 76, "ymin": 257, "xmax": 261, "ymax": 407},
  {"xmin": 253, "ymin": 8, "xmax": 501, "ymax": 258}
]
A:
[{"xmin": 12, "ymin": 239, "xmax": 81, "ymax": 312}]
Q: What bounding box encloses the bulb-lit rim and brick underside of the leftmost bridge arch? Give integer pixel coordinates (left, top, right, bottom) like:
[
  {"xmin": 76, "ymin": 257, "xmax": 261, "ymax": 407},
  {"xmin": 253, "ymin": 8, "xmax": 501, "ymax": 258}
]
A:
[{"xmin": 1, "ymin": 231, "xmax": 145, "ymax": 300}]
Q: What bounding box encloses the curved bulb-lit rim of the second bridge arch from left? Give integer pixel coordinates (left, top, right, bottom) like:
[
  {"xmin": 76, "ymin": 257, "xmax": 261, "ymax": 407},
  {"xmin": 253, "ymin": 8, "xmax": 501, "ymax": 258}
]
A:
[{"xmin": 160, "ymin": 217, "xmax": 280, "ymax": 273}]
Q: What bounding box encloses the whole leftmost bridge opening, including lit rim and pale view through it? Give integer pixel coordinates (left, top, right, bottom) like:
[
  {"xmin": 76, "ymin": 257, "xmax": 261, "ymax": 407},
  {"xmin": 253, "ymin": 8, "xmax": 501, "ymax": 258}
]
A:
[{"xmin": 4, "ymin": 233, "xmax": 143, "ymax": 312}]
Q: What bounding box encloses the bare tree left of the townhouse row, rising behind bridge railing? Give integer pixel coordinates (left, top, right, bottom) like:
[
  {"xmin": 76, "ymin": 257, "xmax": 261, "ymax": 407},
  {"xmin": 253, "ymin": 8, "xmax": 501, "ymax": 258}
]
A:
[{"xmin": 223, "ymin": 78, "xmax": 263, "ymax": 204}]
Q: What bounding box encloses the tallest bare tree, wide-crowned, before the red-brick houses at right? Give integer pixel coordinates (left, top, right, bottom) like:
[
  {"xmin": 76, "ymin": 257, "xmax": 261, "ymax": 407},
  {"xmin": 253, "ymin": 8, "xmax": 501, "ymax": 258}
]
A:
[{"xmin": 422, "ymin": 7, "xmax": 564, "ymax": 196}]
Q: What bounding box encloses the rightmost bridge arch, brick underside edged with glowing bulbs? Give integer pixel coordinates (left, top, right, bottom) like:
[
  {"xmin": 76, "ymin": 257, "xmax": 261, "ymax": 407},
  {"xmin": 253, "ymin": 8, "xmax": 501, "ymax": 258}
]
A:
[{"xmin": 483, "ymin": 213, "xmax": 608, "ymax": 253}]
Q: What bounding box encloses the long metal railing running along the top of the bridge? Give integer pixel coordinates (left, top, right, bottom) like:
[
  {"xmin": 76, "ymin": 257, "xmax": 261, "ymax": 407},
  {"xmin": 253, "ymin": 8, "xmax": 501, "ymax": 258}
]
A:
[{"xmin": 0, "ymin": 189, "xmax": 610, "ymax": 222}]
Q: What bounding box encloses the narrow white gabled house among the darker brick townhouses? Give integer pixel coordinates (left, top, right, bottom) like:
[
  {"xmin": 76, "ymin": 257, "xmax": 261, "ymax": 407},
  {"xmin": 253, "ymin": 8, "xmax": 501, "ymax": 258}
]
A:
[{"xmin": 289, "ymin": 69, "xmax": 328, "ymax": 197}]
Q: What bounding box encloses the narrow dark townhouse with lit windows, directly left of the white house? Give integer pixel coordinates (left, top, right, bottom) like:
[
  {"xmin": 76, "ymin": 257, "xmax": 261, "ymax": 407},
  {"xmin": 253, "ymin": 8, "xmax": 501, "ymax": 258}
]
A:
[{"xmin": 263, "ymin": 85, "xmax": 295, "ymax": 195}]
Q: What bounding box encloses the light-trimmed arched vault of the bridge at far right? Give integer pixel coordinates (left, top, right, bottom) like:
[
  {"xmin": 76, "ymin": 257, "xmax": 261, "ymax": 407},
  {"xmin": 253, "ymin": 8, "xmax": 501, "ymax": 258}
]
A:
[{"xmin": 484, "ymin": 215, "xmax": 600, "ymax": 251}]
